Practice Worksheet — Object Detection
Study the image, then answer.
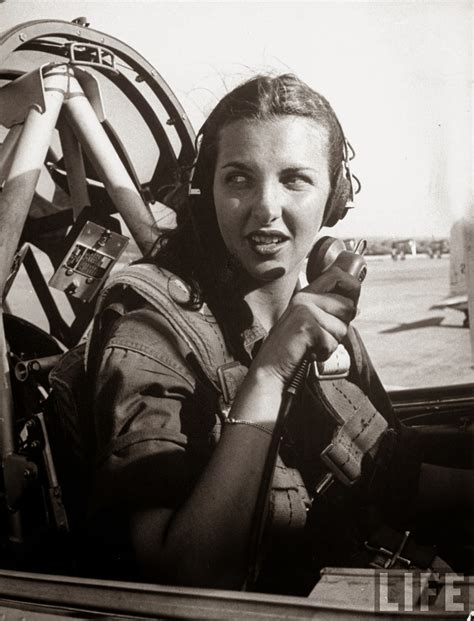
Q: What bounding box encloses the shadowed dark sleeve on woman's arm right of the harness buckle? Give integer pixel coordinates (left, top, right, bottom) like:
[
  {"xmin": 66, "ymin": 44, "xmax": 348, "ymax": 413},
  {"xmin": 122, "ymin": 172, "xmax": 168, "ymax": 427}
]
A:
[{"xmin": 348, "ymin": 328, "xmax": 423, "ymax": 529}]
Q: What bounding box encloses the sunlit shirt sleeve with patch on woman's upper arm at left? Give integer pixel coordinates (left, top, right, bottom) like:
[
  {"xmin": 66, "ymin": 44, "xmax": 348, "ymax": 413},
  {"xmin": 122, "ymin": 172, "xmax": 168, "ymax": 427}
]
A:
[{"xmin": 89, "ymin": 309, "xmax": 218, "ymax": 516}]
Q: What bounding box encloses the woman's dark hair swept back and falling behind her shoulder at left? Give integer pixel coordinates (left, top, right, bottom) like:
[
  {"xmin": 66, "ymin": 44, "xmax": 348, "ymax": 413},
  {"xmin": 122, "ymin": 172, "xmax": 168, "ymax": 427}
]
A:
[{"xmin": 154, "ymin": 74, "xmax": 346, "ymax": 311}]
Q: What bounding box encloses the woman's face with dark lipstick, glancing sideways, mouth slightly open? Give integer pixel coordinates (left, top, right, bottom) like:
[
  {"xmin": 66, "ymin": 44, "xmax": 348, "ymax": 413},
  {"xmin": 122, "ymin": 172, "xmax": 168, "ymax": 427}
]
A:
[{"xmin": 214, "ymin": 116, "xmax": 330, "ymax": 282}]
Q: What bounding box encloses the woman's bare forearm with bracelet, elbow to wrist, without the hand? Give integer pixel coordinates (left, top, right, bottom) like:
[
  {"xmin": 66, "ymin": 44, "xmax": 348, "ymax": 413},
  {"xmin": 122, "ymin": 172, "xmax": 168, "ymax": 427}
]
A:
[{"xmin": 131, "ymin": 368, "xmax": 281, "ymax": 588}]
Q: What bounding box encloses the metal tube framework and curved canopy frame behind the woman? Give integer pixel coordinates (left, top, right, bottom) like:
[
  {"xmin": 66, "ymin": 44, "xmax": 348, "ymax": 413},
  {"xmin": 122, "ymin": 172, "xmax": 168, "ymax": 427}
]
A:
[{"xmin": 0, "ymin": 21, "xmax": 194, "ymax": 544}]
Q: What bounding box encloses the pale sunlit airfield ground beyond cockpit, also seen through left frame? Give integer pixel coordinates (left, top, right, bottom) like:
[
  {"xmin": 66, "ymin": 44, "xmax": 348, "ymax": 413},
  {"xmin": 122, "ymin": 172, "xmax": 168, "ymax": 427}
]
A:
[{"xmin": 8, "ymin": 249, "xmax": 474, "ymax": 388}]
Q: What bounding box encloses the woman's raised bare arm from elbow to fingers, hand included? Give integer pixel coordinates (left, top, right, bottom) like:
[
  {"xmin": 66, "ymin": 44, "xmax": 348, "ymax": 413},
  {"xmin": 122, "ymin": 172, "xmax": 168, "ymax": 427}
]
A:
[{"xmin": 122, "ymin": 268, "xmax": 359, "ymax": 588}]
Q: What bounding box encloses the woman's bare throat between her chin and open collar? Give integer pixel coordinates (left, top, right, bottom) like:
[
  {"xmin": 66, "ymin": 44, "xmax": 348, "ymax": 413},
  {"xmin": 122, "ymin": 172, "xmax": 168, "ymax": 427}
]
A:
[{"xmin": 244, "ymin": 276, "xmax": 298, "ymax": 332}]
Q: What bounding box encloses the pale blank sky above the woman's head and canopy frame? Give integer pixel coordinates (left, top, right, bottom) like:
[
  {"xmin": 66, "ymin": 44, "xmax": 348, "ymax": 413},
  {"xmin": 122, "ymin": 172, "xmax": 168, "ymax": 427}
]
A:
[{"xmin": 0, "ymin": 0, "xmax": 473, "ymax": 237}]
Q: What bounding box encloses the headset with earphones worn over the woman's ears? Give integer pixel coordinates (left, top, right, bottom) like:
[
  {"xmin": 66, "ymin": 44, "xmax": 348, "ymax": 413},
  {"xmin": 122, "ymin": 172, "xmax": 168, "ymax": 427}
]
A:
[{"xmin": 188, "ymin": 115, "xmax": 361, "ymax": 227}]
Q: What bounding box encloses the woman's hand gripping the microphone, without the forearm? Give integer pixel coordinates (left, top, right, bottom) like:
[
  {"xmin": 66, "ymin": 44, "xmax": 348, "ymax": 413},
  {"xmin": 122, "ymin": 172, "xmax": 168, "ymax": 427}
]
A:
[{"xmin": 252, "ymin": 266, "xmax": 360, "ymax": 386}]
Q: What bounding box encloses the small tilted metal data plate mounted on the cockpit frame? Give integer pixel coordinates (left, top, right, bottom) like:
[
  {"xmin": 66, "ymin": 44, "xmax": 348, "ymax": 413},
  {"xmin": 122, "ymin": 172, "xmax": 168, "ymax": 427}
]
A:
[{"xmin": 49, "ymin": 221, "xmax": 128, "ymax": 302}]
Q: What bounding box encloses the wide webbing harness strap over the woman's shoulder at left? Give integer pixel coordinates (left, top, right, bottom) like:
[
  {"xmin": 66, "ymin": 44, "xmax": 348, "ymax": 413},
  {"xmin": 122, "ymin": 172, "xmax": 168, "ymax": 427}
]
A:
[{"xmin": 88, "ymin": 263, "xmax": 245, "ymax": 393}]
